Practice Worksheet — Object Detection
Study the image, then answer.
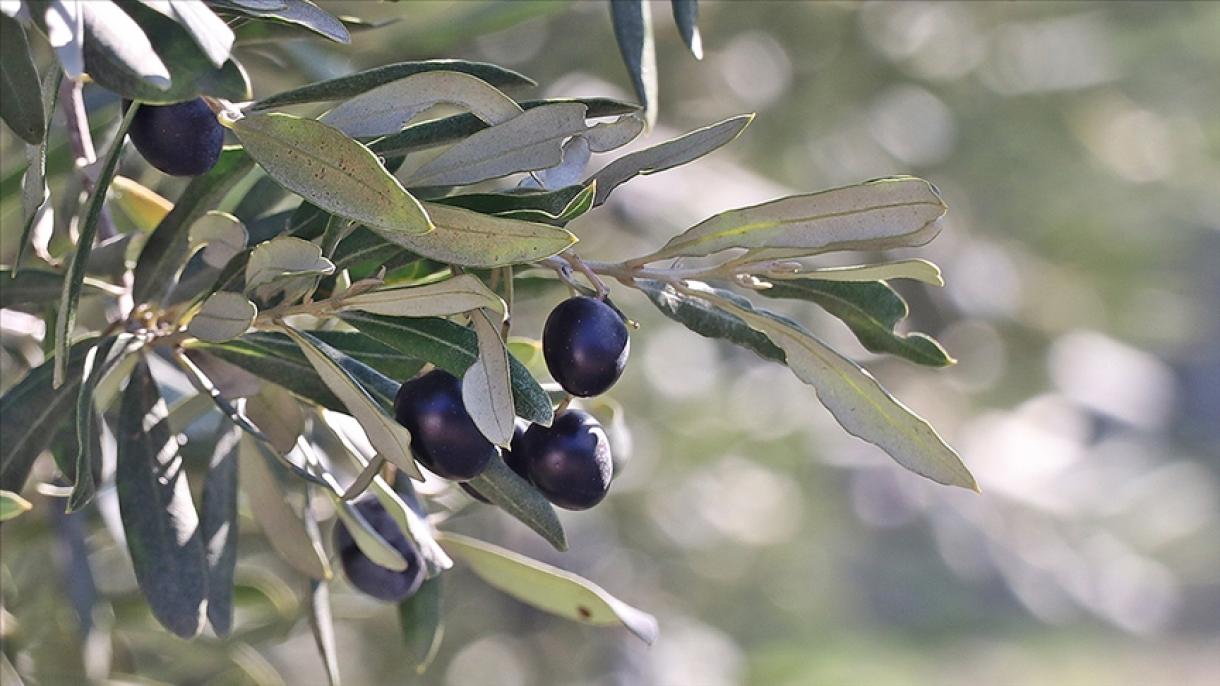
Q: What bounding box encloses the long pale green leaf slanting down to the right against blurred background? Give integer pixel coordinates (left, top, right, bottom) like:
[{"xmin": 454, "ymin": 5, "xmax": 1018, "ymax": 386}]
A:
[{"xmin": 717, "ymin": 290, "xmax": 978, "ymax": 491}]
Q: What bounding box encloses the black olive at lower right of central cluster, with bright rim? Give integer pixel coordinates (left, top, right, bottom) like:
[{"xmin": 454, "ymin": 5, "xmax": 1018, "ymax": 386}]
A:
[{"xmin": 521, "ymin": 410, "xmax": 614, "ymax": 510}]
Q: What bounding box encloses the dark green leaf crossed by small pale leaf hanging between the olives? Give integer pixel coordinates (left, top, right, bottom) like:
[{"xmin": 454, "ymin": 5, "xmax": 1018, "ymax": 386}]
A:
[{"xmin": 339, "ymin": 312, "xmax": 554, "ymax": 426}]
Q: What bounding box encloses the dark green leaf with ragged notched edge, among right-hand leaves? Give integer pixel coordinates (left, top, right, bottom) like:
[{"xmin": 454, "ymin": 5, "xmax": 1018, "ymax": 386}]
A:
[{"xmin": 759, "ymin": 278, "xmax": 954, "ymax": 367}]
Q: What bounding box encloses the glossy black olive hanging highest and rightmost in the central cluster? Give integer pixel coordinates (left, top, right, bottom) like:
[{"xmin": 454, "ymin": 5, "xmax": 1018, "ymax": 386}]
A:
[{"xmin": 542, "ymin": 295, "xmax": 631, "ymax": 398}]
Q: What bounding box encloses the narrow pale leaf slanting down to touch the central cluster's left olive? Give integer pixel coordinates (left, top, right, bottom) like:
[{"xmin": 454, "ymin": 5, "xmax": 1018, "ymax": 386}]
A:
[{"xmin": 284, "ymin": 326, "xmax": 423, "ymax": 480}]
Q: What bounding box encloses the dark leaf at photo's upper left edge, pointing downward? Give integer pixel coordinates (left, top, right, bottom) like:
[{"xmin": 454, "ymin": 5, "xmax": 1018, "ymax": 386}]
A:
[{"xmin": 0, "ymin": 15, "xmax": 46, "ymax": 145}]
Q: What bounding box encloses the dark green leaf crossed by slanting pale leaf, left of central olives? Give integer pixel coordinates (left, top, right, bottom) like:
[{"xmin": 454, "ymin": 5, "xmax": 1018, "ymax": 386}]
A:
[{"xmin": 185, "ymin": 332, "xmax": 424, "ymax": 411}]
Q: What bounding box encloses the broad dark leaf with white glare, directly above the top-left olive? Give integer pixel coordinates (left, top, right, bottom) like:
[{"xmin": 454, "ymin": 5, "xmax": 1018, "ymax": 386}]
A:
[{"xmin": 81, "ymin": 0, "xmax": 251, "ymax": 105}]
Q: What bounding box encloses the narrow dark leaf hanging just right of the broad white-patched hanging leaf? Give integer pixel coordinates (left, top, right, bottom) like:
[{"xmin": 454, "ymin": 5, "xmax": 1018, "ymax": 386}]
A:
[{"xmin": 201, "ymin": 425, "xmax": 242, "ymax": 636}]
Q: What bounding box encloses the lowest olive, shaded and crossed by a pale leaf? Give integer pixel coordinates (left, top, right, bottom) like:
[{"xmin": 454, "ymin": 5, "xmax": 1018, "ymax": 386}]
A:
[{"xmin": 334, "ymin": 498, "xmax": 425, "ymax": 603}]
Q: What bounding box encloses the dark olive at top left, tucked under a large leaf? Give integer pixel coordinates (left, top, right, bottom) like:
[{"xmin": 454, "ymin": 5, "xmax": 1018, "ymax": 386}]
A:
[{"xmin": 124, "ymin": 98, "xmax": 224, "ymax": 176}]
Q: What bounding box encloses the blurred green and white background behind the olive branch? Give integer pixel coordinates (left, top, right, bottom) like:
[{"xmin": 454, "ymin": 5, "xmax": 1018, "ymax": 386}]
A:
[{"xmin": 4, "ymin": 1, "xmax": 1220, "ymax": 686}]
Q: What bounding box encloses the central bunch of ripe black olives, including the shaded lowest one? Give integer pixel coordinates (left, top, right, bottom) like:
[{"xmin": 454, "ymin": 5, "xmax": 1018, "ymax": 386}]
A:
[{"xmin": 336, "ymin": 297, "xmax": 631, "ymax": 601}]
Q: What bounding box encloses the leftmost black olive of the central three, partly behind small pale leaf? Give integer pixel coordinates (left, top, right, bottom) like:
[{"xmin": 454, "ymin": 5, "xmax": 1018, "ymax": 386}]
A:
[{"xmin": 394, "ymin": 369, "xmax": 495, "ymax": 481}]
